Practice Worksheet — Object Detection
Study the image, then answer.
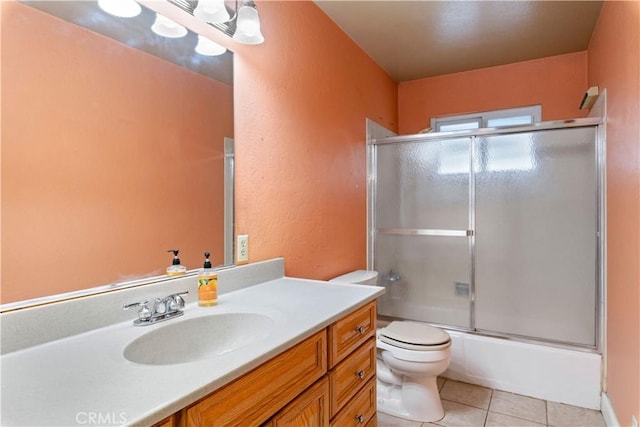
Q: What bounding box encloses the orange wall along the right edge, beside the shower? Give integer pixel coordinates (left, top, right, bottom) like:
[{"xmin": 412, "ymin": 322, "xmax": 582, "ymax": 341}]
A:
[{"xmin": 588, "ymin": 1, "xmax": 640, "ymax": 426}]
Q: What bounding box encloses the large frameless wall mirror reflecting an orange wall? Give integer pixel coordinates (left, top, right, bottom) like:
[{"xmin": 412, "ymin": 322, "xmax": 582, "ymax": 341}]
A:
[{"xmin": 0, "ymin": 1, "xmax": 233, "ymax": 307}]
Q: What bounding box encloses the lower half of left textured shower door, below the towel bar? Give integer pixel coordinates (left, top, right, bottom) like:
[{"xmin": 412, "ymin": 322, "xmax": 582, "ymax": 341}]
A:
[{"xmin": 374, "ymin": 235, "xmax": 469, "ymax": 328}]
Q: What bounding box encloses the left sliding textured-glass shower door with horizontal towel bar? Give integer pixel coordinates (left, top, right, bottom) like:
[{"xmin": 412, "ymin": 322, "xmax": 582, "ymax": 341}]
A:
[{"xmin": 373, "ymin": 138, "xmax": 471, "ymax": 328}]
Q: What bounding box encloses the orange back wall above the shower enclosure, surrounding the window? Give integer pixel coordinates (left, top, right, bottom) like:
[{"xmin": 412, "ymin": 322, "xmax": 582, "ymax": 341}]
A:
[{"xmin": 398, "ymin": 52, "xmax": 587, "ymax": 134}]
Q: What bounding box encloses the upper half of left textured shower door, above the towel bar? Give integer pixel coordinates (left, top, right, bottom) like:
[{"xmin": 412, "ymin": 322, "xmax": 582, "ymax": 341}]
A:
[{"xmin": 376, "ymin": 138, "xmax": 471, "ymax": 230}]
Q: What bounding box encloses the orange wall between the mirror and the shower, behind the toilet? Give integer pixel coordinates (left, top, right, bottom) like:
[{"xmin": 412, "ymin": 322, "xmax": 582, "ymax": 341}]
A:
[{"xmin": 234, "ymin": 1, "xmax": 397, "ymax": 279}]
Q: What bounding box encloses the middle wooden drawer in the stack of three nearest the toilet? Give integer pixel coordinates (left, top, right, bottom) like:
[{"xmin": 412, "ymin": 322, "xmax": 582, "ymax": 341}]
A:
[{"xmin": 329, "ymin": 338, "xmax": 376, "ymax": 417}]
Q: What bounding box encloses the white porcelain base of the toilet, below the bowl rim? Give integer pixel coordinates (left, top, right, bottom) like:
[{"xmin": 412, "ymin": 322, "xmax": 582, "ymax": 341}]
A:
[{"xmin": 377, "ymin": 377, "xmax": 444, "ymax": 423}]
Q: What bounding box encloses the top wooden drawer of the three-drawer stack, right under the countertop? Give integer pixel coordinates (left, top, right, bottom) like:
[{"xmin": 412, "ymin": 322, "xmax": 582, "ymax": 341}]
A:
[{"xmin": 329, "ymin": 301, "xmax": 376, "ymax": 368}]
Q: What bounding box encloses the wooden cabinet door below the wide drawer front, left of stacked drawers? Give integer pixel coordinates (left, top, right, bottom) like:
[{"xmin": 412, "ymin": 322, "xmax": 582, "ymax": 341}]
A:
[{"xmin": 267, "ymin": 377, "xmax": 329, "ymax": 427}]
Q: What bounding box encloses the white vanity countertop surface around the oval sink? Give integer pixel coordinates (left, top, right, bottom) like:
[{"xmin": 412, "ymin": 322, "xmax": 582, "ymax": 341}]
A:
[{"xmin": 0, "ymin": 277, "xmax": 384, "ymax": 426}]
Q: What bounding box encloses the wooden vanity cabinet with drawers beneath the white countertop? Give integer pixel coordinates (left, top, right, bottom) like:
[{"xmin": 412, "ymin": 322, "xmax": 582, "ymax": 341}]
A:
[{"xmin": 172, "ymin": 301, "xmax": 376, "ymax": 427}]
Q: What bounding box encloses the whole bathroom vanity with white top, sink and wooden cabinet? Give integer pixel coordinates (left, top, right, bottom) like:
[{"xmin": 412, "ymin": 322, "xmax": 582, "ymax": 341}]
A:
[{"xmin": 0, "ymin": 259, "xmax": 384, "ymax": 427}]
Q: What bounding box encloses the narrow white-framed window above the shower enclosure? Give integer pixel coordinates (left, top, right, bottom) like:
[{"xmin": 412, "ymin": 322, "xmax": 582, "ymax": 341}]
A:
[{"xmin": 431, "ymin": 105, "xmax": 542, "ymax": 132}]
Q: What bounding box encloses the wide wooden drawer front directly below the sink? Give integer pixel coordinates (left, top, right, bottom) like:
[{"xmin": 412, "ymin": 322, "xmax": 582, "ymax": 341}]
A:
[{"xmin": 185, "ymin": 330, "xmax": 327, "ymax": 427}]
